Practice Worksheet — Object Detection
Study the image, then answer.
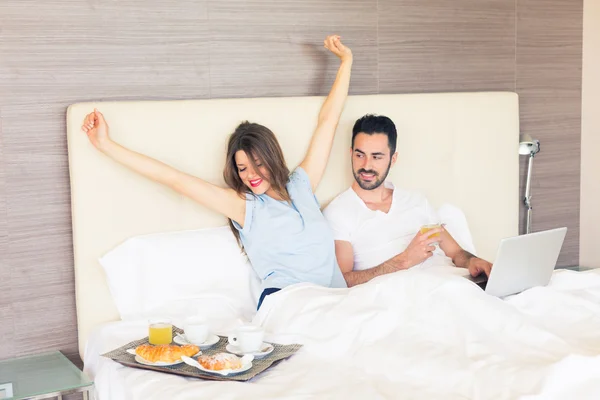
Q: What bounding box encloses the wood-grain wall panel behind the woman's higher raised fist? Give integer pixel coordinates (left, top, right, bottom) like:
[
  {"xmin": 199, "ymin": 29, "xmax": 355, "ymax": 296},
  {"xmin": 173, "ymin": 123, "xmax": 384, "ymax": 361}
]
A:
[{"xmin": 209, "ymin": 0, "xmax": 378, "ymax": 97}]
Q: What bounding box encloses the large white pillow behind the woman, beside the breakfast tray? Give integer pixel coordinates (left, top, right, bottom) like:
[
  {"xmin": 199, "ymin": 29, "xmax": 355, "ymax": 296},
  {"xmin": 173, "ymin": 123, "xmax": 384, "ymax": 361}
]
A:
[{"xmin": 99, "ymin": 226, "xmax": 258, "ymax": 320}]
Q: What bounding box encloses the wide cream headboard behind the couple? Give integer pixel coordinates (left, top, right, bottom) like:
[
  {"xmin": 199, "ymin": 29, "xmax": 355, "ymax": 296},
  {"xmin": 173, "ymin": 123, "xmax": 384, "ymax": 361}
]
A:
[{"xmin": 67, "ymin": 92, "xmax": 519, "ymax": 357}]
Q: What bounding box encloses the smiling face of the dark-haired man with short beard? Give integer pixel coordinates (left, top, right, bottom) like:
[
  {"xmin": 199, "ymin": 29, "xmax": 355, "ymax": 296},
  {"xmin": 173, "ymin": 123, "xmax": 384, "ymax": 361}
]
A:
[{"xmin": 352, "ymin": 133, "xmax": 397, "ymax": 190}]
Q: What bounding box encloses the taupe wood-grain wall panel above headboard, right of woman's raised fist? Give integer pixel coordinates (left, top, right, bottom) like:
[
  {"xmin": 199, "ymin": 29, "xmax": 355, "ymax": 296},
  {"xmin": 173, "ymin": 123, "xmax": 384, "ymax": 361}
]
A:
[{"xmin": 379, "ymin": 0, "xmax": 515, "ymax": 93}]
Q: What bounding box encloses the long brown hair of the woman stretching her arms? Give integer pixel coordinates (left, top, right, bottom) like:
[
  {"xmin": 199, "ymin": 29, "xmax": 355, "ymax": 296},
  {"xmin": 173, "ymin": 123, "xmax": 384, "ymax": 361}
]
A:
[{"xmin": 223, "ymin": 121, "xmax": 290, "ymax": 250}]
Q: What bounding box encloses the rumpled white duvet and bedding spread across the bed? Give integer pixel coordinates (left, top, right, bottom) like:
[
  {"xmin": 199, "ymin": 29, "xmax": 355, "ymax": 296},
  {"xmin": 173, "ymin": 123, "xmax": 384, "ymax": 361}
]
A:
[{"xmin": 85, "ymin": 270, "xmax": 600, "ymax": 400}]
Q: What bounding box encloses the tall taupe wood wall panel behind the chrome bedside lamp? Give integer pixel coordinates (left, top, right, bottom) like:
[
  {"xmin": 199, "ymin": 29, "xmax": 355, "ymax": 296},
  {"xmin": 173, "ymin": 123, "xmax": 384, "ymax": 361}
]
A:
[{"xmin": 516, "ymin": 0, "xmax": 583, "ymax": 265}]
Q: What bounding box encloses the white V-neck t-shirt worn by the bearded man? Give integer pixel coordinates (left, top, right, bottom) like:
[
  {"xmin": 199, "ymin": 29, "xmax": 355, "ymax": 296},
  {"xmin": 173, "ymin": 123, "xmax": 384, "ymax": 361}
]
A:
[{"xmin": 323, "ymin": 181, "xmax": 454, "ymax": 271}]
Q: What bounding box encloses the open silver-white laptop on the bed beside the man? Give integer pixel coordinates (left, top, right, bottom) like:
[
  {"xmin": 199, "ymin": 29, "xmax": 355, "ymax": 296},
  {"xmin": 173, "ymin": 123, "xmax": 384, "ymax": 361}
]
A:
[{"xmin": 468, "ymin": 227, "xmax": 567, "ymax": 297}]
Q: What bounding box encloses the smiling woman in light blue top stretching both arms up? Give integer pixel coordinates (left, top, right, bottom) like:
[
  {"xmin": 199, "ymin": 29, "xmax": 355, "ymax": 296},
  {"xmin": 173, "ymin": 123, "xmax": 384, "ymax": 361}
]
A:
[{"xmin": 82, "ymin": 35, "xmax": 352, "ymax": 308}]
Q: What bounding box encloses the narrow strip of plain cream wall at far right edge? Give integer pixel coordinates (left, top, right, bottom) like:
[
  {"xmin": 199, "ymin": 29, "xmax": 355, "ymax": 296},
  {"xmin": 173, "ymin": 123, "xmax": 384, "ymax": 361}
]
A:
[{"xmin": 579, "ymin": 0, "xmax": 600, "ymax": 267}]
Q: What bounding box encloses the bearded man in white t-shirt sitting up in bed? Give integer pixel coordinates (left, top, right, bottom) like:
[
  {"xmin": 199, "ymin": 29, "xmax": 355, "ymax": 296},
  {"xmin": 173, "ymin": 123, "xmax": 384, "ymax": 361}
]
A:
[{"xmin": 324, "ymin": 115, "xmax": 492, "ymax": 287}]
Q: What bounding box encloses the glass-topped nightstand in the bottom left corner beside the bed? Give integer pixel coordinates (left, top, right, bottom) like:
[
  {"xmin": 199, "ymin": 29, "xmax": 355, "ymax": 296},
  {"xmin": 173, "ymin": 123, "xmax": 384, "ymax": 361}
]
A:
[{"xmin": 0, "ymin": 351, "xmax": 94, "ymax": 400}]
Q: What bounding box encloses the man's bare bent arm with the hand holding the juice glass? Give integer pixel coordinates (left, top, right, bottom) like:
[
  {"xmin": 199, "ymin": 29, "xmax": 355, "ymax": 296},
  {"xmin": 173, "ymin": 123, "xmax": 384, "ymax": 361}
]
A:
[{"xmin": 335, "ymin": 228, "xmax": 441, "ymax": 287}]
